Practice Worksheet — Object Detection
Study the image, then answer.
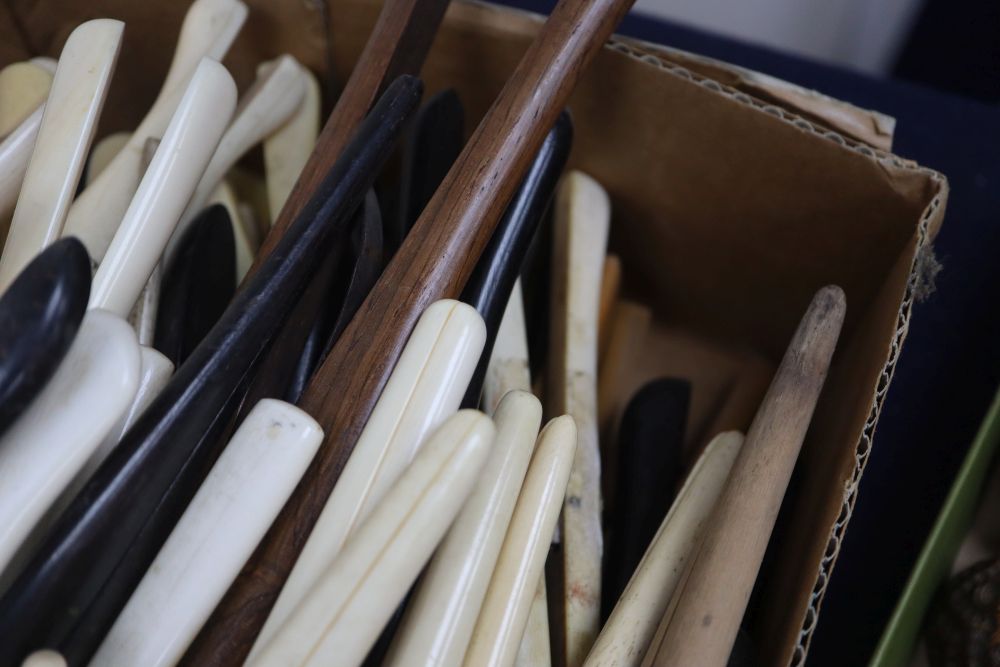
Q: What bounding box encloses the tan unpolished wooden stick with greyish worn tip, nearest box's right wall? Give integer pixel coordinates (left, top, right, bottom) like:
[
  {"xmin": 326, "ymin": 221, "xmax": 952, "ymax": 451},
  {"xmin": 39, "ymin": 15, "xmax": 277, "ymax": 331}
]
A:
[{"xmin": 652, "ymin": 286, "xmax": 846, "ymax": 667}]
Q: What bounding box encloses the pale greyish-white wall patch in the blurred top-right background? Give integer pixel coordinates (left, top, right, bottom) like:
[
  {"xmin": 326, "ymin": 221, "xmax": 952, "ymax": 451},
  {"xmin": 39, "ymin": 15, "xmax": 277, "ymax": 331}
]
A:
[{"xmin": 635, "ymin": 0, "xmax": 921, "ymax": 74}]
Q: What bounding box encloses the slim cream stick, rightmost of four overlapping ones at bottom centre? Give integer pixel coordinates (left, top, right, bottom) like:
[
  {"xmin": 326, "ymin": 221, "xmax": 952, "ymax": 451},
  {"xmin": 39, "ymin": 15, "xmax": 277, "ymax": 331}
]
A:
[{"xmin": 464, "ymin": 415, "xmax": 577, "ymax": 667}]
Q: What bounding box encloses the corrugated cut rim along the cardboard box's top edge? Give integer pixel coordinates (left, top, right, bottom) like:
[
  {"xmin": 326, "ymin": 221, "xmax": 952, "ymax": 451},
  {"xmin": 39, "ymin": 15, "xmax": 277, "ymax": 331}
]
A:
[{"xmin": 606, "ymin": 37, "xmax": 948, "ymax": 667}]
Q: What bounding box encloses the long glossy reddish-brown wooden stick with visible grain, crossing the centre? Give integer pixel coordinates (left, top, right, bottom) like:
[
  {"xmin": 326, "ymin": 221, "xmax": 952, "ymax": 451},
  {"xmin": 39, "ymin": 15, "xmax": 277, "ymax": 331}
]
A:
[{"xmin": 195, "ymin": 0, "xmax": 631, "ymax": 664}]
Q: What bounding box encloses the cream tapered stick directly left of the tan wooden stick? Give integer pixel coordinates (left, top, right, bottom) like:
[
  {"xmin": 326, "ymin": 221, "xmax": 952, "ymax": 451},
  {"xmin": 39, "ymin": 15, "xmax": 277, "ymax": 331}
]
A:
[{"xmin": 584, "ymin": 431, "xmax": 743, "ymax": 667}]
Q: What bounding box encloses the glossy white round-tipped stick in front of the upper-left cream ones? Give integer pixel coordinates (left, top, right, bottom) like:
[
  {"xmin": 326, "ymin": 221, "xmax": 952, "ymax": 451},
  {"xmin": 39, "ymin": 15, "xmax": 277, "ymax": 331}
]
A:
[{"xmin": 84, "ymin": 58, "xmax": 236, "ymax": 317}]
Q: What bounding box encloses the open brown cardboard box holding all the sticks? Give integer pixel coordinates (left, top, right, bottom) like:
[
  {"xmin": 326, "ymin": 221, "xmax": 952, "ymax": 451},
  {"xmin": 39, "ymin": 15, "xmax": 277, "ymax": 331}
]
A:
[{"xmin": 0, "ymin": 0, "xmax": 947, "ymax": 665}]
